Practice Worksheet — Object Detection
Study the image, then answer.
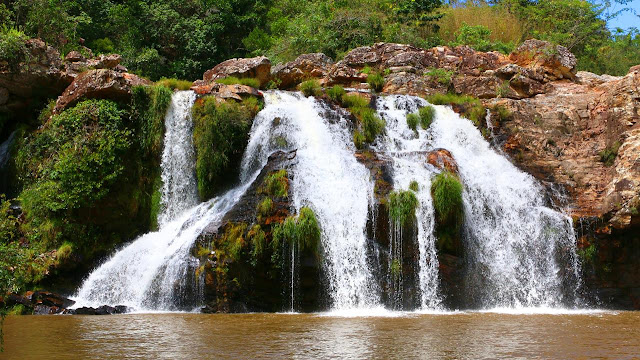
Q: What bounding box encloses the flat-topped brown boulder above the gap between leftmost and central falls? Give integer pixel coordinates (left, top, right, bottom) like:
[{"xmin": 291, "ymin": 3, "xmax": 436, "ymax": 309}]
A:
[{"xmin": 203, "ymin": 56, "xmax": 271, "ymax": 85}]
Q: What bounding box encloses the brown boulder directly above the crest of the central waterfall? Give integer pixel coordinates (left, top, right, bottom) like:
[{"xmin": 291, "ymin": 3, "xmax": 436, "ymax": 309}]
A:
[{"xmin": 271, "ymin": 53, "xmax": 333, "ymax": 89}]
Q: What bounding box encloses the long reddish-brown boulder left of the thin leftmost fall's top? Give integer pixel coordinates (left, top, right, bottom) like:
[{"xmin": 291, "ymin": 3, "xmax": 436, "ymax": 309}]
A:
[{"xmin": 53, "ymin": 69, "xmax": 151, "ymax": 114}]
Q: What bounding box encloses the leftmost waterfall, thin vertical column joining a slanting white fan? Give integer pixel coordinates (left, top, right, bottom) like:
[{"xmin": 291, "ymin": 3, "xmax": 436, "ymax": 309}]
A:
[{"xmin": 75, "ymin": 91, "xmax": 250, "ymax": 311}]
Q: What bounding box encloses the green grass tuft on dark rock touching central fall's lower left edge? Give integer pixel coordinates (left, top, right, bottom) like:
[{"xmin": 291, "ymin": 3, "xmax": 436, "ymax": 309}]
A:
[{"xmin": 273, "ymin": 206, "xmax": 321, "ymax": 255}]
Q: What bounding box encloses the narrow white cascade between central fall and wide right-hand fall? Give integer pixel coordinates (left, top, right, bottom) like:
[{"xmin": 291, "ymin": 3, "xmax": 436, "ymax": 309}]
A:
[{"xmin": 374, "ymin": 95, "xmax": 441, "ymax": 309}]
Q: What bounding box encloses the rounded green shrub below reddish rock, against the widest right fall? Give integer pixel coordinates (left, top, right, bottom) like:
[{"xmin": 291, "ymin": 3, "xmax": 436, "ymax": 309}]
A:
[{"xmin": 431, "ymin": 171, "xmax": 464, "ymax": 226}]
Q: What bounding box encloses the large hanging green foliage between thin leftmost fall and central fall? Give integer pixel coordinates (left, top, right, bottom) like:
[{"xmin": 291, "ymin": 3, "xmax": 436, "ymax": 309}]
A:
[{"xmin": 192, "ymin": 97, "xmax": 259, "ymax": 200}]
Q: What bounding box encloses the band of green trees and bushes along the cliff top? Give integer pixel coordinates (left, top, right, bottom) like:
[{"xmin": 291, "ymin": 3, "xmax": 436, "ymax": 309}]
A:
[{"xmin": 0, "ymin": 0, "xmax": 640, "ymax": 80}]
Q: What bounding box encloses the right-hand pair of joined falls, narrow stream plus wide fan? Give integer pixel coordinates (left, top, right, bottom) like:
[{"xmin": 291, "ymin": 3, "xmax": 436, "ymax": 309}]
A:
[{"xmin": 377, "ymin": 96, "xmax": 579, "ymax": 308}]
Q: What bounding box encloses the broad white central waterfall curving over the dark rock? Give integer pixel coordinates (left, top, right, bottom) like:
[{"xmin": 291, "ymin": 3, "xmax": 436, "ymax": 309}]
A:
[{"xmin": 243, "ymin": 92, "xmax": 378, "ymax": 309}]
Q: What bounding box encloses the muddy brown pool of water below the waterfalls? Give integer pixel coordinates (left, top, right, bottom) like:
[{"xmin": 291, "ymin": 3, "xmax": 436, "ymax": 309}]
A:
[{"xmin": 0, "ymin": 312, "xmax": 640, "ymax": 359}]
